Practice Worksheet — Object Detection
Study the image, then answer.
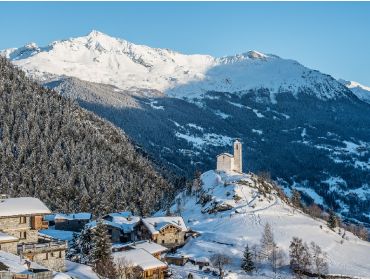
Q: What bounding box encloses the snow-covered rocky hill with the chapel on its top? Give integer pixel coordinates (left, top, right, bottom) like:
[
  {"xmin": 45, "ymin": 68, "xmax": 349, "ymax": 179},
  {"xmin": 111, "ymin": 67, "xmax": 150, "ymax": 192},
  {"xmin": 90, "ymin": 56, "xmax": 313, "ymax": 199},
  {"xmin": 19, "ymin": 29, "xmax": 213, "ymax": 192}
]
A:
[{"xmin": 163, "ymin": 170, "xmax": 370, "ymax": 278}]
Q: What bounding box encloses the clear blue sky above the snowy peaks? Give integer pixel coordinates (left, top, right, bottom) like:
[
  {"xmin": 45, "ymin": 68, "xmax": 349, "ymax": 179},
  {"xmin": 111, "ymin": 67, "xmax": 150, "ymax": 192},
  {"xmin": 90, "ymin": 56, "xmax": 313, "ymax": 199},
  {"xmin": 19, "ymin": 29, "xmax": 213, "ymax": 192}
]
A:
[{"xmin": 0, "ymin": 2, "xmax": 370, "ymax": 85}]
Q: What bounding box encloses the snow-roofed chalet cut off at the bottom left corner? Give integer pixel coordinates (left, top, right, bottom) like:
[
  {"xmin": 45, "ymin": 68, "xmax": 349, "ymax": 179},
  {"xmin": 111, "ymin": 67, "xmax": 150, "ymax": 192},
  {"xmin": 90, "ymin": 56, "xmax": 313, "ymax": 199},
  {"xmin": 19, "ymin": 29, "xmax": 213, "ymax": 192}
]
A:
[{"xmin": 0, "ymin": 251, "xmax": 53, "ymax": 279}]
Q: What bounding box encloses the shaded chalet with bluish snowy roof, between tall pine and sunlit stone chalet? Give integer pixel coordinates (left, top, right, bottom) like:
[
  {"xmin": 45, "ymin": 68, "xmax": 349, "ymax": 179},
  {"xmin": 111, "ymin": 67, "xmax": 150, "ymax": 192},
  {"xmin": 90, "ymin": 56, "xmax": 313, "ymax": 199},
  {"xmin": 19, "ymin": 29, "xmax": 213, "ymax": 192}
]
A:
[{"xmin": 88, "ymin": 212, "xmax": 140, "ymax": 243}]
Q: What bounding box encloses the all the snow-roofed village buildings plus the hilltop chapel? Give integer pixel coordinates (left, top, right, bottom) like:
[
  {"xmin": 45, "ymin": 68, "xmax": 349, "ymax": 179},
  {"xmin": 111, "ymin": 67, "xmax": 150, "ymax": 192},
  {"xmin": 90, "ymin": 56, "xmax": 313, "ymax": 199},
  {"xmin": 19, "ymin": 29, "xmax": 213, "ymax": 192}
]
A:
[{"xmin": 0, "ymin": 140, "xmax": 242, "ymax": 279}]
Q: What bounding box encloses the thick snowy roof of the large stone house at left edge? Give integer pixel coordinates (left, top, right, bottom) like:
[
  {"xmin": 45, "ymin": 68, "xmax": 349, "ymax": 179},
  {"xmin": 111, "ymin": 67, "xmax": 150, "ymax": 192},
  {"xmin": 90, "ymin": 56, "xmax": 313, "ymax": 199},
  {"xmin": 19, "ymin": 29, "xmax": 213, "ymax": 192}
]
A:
[{"xmin": 0, "ymin": 197, "xmax": 50, "ymax": 217}]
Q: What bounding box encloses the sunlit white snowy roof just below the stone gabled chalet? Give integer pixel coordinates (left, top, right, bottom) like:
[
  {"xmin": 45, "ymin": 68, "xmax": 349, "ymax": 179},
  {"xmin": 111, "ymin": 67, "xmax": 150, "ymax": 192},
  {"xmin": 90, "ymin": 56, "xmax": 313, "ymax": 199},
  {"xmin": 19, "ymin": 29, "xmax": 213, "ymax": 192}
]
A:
[{"xmin": 112, "ymin": 249, "xmax": 167, "ymax": 270}]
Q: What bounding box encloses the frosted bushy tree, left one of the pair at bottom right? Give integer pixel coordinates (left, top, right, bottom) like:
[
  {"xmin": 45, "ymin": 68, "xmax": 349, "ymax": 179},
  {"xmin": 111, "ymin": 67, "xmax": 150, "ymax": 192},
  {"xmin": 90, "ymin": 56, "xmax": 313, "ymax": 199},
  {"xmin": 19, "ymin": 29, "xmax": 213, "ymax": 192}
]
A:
[{"xmin": 289, "ymin": 237, "xmax": 311, "ymax": 276}]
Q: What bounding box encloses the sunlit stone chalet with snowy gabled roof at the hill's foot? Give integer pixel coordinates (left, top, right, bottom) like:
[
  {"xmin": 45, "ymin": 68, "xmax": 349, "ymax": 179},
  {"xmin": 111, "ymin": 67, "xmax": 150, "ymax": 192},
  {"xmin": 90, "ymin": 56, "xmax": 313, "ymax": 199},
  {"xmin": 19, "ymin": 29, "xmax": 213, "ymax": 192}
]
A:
[{"xmin": 138, "ymin": 217, "xmax": 188, "ymax": 248}]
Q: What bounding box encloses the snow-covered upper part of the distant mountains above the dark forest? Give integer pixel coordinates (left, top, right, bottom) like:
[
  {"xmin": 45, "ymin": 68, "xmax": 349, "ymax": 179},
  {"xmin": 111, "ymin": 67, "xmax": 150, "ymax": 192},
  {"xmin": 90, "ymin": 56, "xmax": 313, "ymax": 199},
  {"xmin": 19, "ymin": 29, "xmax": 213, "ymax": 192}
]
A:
[{"xmin": 0, "ymin": 30, "xmax": 343, "ymax": 101}]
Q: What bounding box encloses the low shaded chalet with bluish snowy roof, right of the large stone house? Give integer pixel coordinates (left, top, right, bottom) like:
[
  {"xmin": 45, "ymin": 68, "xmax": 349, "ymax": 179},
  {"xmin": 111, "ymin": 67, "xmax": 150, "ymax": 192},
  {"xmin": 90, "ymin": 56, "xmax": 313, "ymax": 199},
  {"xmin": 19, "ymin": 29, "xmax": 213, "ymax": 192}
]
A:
[{"xmin": 54, "ymin": 213, "xmax": 92, "ymax": 232}]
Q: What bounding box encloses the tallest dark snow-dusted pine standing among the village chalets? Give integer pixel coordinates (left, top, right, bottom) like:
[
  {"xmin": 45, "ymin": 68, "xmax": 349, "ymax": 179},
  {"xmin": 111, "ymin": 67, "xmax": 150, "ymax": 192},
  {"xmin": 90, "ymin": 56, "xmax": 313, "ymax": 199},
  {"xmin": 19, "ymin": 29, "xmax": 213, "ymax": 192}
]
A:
[{"xmin": 91, "ymin": 220, "xmax": 116, "ymax": 278}]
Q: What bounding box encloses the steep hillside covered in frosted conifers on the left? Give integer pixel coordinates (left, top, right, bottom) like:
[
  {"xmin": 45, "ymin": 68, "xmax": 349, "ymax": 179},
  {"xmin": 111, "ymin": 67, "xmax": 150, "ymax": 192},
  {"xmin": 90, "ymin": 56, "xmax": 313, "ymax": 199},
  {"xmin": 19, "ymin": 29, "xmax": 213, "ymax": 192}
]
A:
[{"xmin": 0, "ymin": 56, "xmax": 172, "ymax": 214}]
